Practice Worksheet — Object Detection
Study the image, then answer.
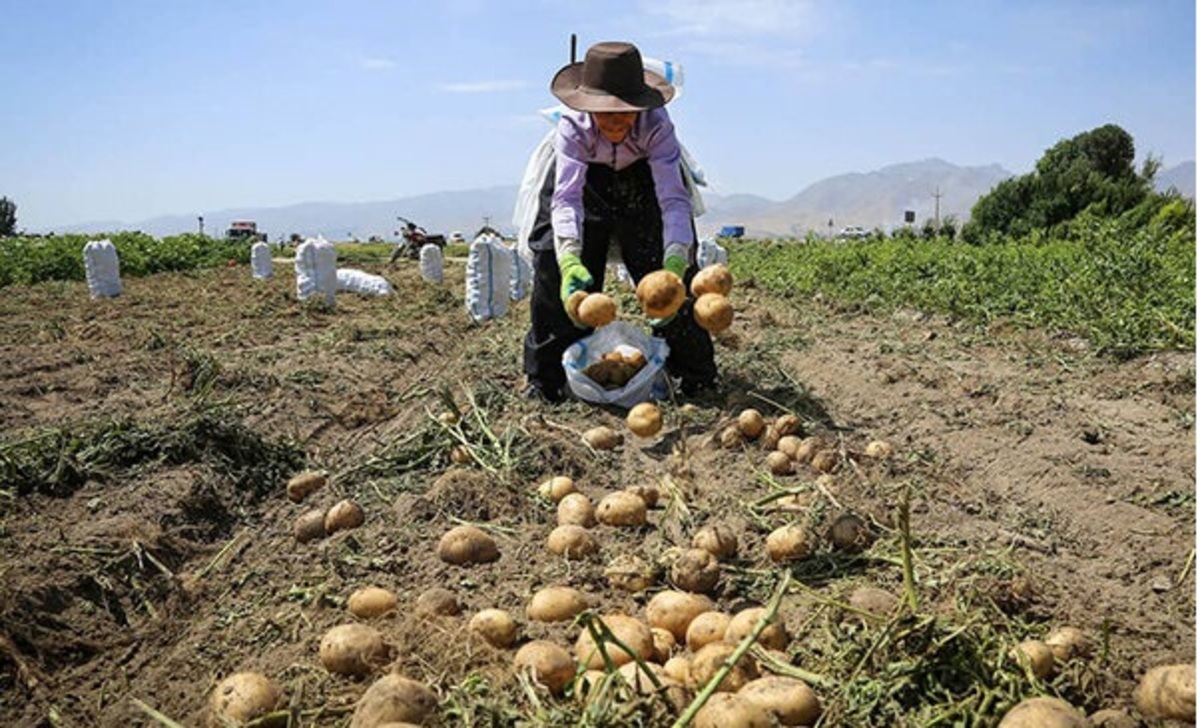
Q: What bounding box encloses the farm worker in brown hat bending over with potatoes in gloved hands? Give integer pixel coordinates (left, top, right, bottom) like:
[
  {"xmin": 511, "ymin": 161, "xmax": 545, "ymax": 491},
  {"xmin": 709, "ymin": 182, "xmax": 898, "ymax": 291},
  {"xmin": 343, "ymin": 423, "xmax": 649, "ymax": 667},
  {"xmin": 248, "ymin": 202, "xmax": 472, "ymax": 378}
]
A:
[{"xmin": 524, "ymin": 42, "xmax": 716, "ymax": 402}]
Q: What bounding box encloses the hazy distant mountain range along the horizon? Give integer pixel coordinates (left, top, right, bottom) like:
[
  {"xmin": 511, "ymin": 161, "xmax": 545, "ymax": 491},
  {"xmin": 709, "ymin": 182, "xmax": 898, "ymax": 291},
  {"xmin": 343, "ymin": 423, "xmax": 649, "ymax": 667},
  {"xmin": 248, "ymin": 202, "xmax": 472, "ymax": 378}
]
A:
[{"xmin": 46, "ymin": 158, "xmax": 1195, "ymax": 241}]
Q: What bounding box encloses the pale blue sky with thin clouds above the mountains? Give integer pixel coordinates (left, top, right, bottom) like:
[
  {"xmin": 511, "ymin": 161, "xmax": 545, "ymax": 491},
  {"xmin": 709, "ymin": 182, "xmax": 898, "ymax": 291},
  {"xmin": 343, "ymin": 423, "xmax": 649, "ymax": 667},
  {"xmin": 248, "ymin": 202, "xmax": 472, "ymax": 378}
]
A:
[{"xmin": 0, "ymin": 0, "xmax": 1196, "ymax": 230}]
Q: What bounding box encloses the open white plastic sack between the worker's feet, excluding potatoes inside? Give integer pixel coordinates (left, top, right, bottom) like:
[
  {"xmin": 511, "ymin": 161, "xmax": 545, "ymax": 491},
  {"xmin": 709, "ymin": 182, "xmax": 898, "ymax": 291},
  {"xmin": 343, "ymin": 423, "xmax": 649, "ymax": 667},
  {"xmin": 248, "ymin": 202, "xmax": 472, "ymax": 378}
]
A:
[{"xmin": 563, "ymin": 321, "xmax": 671, "ymax": 409}]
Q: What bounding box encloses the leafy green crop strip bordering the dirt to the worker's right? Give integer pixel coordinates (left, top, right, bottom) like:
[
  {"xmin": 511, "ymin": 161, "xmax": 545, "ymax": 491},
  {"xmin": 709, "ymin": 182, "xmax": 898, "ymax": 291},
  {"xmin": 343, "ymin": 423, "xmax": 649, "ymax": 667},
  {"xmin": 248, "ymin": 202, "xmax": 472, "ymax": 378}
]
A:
[{"xmin": 730, "ymin": 218, "xmax": 1195, "ymax": 357}]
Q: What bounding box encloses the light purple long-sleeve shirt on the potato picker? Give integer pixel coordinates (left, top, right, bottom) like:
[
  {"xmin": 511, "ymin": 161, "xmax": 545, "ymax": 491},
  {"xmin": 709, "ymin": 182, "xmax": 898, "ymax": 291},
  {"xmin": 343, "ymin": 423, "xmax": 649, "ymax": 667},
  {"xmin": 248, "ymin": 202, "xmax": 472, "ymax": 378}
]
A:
[{"xmin": 551, "ymin": 108, "xmax": 695, "ymax": 247}]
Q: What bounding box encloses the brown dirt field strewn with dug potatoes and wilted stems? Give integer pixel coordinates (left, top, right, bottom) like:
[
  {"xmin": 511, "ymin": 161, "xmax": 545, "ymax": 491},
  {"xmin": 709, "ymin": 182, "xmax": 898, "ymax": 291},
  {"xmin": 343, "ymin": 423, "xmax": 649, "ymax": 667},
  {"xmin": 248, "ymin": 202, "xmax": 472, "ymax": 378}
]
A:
[{"xmin": 0, "ymin": 261, "xmax": 1195, "ymax": 727}]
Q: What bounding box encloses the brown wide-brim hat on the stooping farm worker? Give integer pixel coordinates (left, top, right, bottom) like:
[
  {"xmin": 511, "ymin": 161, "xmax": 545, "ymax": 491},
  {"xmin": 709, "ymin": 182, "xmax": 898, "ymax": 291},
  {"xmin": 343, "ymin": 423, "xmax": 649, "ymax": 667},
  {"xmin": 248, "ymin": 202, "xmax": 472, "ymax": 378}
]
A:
[{"xmin": 550, "ymin": 42, "xmax": 674, "ymax": 112}]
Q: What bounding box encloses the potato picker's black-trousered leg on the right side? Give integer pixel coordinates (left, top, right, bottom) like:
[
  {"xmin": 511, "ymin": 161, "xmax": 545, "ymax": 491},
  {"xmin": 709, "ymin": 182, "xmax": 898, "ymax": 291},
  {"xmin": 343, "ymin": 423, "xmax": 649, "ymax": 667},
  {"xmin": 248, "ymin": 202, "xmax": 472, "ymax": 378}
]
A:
[{"xmin": 616, "ymin": 162, "xmax": 716, "ymax": 395}]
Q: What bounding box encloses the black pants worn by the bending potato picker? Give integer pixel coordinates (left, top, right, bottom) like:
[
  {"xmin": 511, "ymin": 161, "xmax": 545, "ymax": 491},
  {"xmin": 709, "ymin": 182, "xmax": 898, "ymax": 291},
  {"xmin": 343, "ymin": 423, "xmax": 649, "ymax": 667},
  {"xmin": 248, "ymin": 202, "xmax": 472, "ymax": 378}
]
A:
[{"xmin": 524, "ymin": 160, "xmax": 716, "ymax": 397}]
